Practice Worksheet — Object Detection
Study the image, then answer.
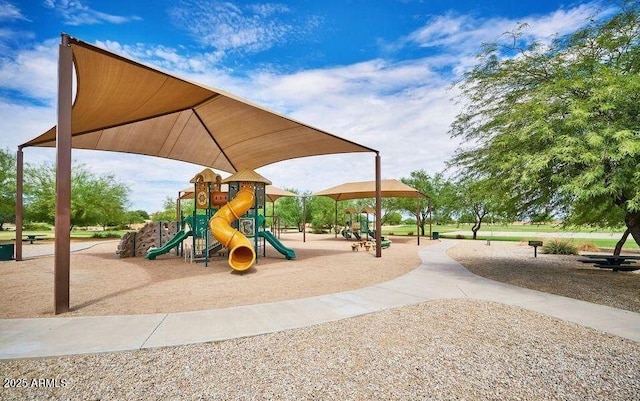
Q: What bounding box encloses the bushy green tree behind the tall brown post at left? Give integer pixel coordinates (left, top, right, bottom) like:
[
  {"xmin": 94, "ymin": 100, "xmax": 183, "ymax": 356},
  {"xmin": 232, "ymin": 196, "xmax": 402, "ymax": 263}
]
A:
[{"xmin": 24, "ymin": 163, "xmax": 128, "ymax": 227}]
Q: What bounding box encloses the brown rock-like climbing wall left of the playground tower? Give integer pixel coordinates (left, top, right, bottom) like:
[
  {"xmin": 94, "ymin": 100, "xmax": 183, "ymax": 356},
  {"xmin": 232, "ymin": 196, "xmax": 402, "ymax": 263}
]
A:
[{"xmin": 116, "ymin": 222, "xmax": 178, "ymax": 258}]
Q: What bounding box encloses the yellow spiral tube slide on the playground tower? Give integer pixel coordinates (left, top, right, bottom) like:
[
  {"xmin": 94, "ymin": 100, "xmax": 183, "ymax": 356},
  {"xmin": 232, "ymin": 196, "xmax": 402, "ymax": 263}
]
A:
[{"xmin": 209, "ymin": 188, "xmax": 256, "ymax": 271}]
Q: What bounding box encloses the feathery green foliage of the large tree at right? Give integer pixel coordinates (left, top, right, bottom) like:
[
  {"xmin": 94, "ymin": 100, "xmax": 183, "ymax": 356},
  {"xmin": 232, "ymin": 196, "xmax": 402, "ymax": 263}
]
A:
[{"xmin": 450, "ymin": 1, "xmax": 640, "ymax": 253}]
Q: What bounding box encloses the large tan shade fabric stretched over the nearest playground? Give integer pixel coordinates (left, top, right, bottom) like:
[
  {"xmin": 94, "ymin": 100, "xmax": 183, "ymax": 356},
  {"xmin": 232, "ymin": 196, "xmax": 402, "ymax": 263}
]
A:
[{"xmin": 22, "ymin": 39, "xmax": 377, "ymax": 173}]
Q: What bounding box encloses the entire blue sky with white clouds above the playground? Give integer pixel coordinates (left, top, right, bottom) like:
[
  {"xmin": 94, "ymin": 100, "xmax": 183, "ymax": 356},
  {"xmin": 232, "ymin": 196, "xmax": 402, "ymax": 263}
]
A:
[{"xmin": 0, "ymin": 0, "xmax": 613, "ymax": 212}]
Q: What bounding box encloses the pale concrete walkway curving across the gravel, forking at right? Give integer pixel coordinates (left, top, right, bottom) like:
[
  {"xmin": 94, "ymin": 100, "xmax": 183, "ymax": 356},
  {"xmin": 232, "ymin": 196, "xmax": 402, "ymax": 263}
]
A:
[{"xmin": 0, "ymin": 241, "xmax": 640, "ymax": 359}]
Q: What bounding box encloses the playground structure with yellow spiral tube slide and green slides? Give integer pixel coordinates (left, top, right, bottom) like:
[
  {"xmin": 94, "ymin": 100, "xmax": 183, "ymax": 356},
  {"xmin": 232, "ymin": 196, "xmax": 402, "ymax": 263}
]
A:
[{"xmin": 132, "ymin": 169, "xmax": 296, "ymax": 272}]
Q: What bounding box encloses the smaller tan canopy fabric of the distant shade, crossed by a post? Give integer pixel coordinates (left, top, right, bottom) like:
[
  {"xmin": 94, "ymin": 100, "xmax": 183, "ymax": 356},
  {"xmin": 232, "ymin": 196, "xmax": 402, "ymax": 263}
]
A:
[{"xmin": 312, "ymin": 180, "xmax": 427, "ymax": 201}]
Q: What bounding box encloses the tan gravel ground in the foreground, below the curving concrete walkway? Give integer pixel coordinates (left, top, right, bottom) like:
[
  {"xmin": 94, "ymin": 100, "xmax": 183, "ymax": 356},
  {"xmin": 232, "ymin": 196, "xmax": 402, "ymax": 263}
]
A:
[{"xmin": 0, "ymin": 300, "xmax": 640, "ymax": 400}]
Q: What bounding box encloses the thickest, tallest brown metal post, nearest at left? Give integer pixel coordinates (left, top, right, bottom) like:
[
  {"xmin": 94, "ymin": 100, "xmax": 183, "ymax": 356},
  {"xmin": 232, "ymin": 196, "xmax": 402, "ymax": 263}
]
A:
[{"xmin": 54, "ymin": 34, "xmax": 73, "ymax": 315}]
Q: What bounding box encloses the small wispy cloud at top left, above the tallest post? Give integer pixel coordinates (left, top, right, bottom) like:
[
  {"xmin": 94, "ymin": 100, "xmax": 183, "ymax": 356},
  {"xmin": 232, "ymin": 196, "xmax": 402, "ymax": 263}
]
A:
[{"xmin": 43, "ymin": 0, "xmax": 141, "ymax": 26}]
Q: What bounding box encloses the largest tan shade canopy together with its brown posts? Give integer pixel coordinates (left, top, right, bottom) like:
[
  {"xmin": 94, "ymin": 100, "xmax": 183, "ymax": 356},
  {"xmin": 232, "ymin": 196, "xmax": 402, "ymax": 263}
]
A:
[{"xmin": 16, "ymin": 34, "xmax": 381, "ymax": 314}]
